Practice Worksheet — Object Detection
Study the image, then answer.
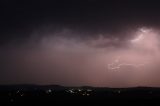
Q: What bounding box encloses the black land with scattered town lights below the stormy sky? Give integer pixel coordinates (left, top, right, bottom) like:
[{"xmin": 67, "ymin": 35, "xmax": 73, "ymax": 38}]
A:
[{"xmin": 0, "ymin": 85, "xmax": 160, "ymax": 105}]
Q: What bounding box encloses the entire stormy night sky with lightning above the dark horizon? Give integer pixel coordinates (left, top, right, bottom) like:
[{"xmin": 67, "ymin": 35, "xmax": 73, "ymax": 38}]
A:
[{"xmin": 0, "ymin": 0, "xmax": 160, "ymax": 87}]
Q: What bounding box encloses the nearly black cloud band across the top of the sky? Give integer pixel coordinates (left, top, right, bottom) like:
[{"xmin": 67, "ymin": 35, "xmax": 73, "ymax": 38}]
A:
[{"xmin": 0, "ymin": 0, "xmax": 160, "ymax": 42}]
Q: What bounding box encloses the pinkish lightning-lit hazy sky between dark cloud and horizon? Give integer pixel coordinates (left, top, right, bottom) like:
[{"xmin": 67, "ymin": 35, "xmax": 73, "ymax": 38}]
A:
[{"xmin": 0, "ymin": 28, "xmax": 160, "ymax": 87}]
